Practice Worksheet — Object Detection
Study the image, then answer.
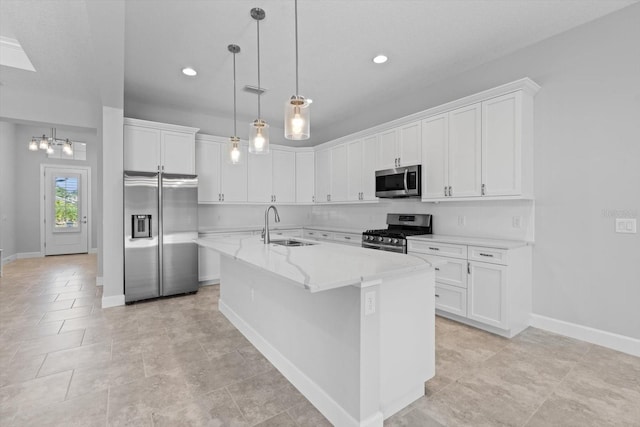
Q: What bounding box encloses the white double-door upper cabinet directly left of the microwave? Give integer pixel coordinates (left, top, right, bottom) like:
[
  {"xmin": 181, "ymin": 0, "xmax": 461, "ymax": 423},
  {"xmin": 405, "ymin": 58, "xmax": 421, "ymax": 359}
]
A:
[{"xmin": 347, "ymin": 135, "xmax": 378, "ymax": 201}]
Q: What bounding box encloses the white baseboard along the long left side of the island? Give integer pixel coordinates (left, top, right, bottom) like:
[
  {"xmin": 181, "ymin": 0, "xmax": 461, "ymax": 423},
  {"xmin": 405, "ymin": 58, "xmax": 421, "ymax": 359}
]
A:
[{"xmin": 218, "ymin": 300, "xmax": 383, "ymax": 427}]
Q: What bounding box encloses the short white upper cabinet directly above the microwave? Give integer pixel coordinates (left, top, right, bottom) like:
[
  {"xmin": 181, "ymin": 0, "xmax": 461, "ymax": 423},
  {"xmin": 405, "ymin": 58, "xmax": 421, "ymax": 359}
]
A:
[{"xmin": 378, "ymin": 122, "xmax": 422, "ymax": 169}]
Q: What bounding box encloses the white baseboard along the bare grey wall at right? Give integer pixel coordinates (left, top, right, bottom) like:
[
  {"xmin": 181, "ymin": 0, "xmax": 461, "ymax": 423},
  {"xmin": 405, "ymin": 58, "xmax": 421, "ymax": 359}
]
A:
[{"xmin": 531, "ymin": 314, "xmax": 640, "ymax": 357}]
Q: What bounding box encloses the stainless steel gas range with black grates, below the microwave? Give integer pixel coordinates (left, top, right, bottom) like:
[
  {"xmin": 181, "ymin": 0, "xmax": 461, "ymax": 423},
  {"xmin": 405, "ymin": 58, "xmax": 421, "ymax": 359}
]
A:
[{"xmin": 362, "ymin": 214, "xmax": 433, "ymax": 254}]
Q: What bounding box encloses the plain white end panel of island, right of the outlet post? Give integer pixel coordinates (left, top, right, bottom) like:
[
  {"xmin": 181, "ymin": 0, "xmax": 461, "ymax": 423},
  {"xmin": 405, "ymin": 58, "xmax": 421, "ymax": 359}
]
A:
[{"xmin": 380, "ymin": 269, "xmax": 435, "ymax": 419}]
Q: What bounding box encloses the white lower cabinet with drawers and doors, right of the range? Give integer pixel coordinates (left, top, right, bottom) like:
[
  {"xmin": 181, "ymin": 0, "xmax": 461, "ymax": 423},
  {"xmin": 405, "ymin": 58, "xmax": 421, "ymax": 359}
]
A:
[{"xmin": 408, "ymin": 238, "xmax": 532, "ymax": 338}]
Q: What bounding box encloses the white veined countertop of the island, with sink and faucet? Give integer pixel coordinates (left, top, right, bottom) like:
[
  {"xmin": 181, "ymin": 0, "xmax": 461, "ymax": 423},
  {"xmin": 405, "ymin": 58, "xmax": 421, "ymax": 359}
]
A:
[{"xmin": 196, "ymin": 236, "xmax": 433, "ymax": 292}]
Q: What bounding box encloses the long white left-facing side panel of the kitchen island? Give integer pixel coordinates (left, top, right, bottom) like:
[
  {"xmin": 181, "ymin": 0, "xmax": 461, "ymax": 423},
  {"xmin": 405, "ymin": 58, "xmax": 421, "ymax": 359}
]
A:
[{"xmin": 219, "ymin": 255, "xmax": 382, "ymax": 426}]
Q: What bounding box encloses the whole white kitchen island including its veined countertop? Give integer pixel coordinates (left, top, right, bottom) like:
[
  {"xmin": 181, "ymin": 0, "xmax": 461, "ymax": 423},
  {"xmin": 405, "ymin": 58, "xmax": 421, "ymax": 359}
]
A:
[{"xmin": 197, "ymin": 236, "xmax": 435, "ymax": 426}]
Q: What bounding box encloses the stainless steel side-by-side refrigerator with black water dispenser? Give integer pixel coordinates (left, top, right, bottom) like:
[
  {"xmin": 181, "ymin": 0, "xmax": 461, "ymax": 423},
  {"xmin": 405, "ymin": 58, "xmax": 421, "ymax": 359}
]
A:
[{"xmin": 124, "ymin": 171, "xmax": 198, "ymax": 303}]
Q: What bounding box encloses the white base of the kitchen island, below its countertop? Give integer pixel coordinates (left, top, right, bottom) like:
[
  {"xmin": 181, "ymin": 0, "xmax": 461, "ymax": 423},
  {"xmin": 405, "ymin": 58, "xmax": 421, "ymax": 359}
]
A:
[{"xmin": 219, "ymin": 255, "xmax": 435, "ymax": 427}]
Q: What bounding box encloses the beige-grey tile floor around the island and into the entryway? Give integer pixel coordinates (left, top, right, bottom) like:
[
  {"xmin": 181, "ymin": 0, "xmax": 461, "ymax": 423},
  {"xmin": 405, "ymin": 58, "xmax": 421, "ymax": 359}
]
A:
[{"xmin": 0, "ymin": 255, "xmax": 640, "ymax": 427}]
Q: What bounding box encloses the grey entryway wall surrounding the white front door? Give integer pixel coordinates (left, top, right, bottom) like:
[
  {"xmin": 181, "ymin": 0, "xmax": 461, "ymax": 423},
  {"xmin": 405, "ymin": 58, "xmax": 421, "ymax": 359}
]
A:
[{"xmin": 11, "ymin": 124, "xmax": 101, "ymax": 253}]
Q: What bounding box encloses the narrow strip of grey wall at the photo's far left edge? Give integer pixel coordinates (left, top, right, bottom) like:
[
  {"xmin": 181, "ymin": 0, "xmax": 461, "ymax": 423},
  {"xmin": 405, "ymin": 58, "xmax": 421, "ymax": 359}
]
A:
[{"xmin": 0, "ymin": 121, "xmax": 17, "ymax": 262}]
